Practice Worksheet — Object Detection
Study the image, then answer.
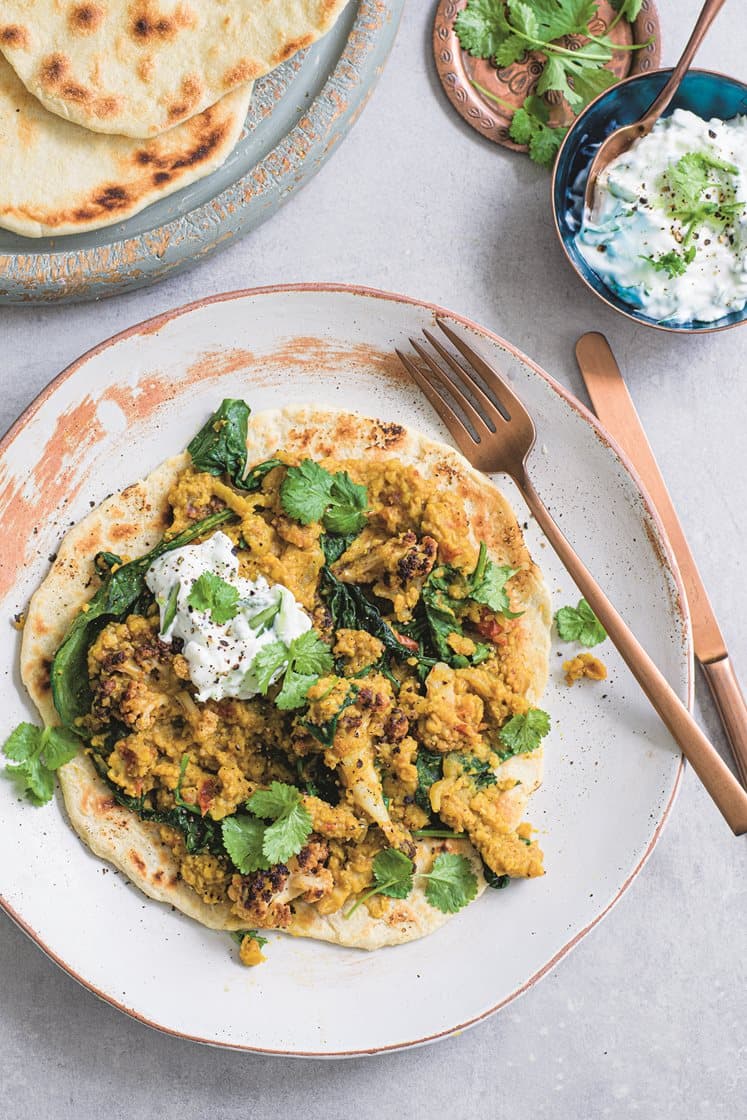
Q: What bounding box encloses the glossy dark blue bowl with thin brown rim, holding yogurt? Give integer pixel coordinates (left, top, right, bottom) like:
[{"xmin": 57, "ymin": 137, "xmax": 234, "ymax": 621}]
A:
[{"xmin": 552, "ymin": 69, "xmax": 747, "ymax": 334}]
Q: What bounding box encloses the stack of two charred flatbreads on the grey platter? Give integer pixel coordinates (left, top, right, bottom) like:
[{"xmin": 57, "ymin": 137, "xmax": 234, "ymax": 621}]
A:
[{"xmin": 0, "ymin": 0, "xmax": 347, "ymax": 237}]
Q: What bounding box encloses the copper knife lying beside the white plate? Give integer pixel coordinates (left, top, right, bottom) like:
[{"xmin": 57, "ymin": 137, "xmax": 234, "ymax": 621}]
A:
[{"xmin": 576, "ymin": 330, "xmax": 747, "ymax": 786}]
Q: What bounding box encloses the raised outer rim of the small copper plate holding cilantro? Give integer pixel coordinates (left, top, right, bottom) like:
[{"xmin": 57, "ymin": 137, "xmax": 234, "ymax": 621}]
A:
[{"xmin": 432, "ymin": 0, "xmax": 662, "ymax": 152}]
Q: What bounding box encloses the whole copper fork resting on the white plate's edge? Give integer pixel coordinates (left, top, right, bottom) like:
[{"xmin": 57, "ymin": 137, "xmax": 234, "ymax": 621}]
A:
[{"xmin": 396, "ymin": 319, "xmax": 747, "ymax": 836}]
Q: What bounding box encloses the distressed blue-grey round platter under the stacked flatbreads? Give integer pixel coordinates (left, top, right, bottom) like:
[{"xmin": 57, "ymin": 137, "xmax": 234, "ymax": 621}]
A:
[{"xmin": 0, "ymin": 0, "xmax": 404, "ymax": 304}]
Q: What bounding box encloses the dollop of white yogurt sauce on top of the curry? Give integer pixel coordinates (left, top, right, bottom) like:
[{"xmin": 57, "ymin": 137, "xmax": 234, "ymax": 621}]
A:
[{"xmin": 146, "ymin": 531, "xmax": 311, "ymax": 701}]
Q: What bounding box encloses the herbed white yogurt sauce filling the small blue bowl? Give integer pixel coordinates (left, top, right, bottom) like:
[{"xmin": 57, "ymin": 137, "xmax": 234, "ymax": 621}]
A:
[{"xmin": 575, "ymin": 109, "xmax": 747, "ymax": 323}]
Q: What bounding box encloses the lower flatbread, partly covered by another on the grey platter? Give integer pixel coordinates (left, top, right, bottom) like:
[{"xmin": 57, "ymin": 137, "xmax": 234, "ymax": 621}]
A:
[{"xmin": 0, "ymin": 56, "xmax": 252, "ymax": 237}]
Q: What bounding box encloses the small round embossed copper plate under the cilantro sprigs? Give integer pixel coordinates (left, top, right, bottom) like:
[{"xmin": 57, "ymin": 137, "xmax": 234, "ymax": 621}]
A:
[{"xmin": 433, "ymin": 0, "xmax": 661, "ymax": 151}]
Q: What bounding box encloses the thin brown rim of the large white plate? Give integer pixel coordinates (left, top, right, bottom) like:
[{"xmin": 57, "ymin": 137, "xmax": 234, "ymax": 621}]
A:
[{"xmin": 0, "ymin": 283, "xmax": 694, "ymax": 1060}]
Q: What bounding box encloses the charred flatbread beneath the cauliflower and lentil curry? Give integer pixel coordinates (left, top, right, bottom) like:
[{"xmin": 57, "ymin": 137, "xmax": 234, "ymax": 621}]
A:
[{"xmin": 21, "ymin": 407, "xmax": 551, "ymax": 949}]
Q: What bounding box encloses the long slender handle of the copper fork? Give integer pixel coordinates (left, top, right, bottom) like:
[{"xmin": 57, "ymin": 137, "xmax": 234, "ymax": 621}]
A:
[{"xmin": 515, "ymin": 474, "xmax": 747, "ymax": 836}]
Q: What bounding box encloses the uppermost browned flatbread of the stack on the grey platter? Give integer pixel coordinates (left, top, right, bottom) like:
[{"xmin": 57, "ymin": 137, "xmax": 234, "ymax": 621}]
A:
[{"xmin": 0, "ymin": 0, "xmax": 347, "ymax": 137}]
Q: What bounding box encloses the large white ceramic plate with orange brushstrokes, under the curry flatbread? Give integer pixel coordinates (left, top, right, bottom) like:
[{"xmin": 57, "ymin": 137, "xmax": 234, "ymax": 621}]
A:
[{"xmin": 0, "ymin": 287, "xmax": 691, "ymax": 1055}]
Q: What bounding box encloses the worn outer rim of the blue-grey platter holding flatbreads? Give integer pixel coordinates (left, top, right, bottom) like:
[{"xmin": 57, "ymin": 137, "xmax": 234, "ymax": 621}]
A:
[{"xmin": 0, "ymin": 0, "xmax": 404, "ymax": 306}]
